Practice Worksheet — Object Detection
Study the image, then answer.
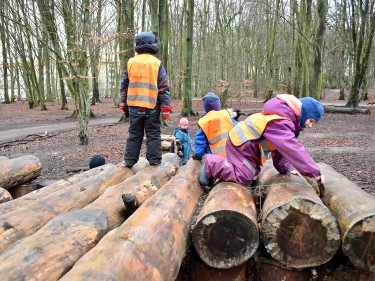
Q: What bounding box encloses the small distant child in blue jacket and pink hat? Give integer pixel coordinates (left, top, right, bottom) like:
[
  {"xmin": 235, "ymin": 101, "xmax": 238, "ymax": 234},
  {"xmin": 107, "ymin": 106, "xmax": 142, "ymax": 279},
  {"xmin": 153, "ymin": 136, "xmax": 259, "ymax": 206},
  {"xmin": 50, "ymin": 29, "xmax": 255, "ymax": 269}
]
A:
[{"xmin": 169, "ymin": 118, "xmax": 191, "ymax": 165}]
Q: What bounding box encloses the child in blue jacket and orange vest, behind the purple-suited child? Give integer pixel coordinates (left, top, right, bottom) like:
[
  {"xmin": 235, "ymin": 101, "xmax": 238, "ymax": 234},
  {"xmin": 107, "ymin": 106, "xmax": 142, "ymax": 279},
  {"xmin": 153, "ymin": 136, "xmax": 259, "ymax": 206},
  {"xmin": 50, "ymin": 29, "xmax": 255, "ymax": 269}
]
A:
[{"xmin": 193, "ymin": 92, "xmax": 238, "ymax": 160}]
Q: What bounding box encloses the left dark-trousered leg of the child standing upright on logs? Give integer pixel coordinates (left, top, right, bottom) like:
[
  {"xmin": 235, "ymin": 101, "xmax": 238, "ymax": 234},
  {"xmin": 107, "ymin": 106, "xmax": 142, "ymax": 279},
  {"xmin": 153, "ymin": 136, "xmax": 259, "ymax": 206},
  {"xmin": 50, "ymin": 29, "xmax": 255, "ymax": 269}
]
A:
[{"xmin": 125, "ymin": 116, "xmax": 144, "ymax": 166}]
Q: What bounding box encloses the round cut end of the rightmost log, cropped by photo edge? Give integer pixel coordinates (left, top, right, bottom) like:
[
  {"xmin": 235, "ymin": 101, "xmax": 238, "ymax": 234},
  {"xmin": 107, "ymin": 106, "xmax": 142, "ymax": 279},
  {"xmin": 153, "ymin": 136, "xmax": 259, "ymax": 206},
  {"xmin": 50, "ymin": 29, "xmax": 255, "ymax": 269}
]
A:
[{"xmin": 342, "ymin": 215, "xmax": 375, "ymax": 272}]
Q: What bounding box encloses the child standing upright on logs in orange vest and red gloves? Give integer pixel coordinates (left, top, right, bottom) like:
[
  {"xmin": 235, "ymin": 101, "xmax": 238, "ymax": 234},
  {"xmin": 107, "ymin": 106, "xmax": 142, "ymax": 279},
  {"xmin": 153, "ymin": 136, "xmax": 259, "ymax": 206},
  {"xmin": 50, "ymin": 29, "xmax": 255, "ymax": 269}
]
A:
[{"xmin": 120, "ymin": 32, "xmax": 172, "ymax": 168}]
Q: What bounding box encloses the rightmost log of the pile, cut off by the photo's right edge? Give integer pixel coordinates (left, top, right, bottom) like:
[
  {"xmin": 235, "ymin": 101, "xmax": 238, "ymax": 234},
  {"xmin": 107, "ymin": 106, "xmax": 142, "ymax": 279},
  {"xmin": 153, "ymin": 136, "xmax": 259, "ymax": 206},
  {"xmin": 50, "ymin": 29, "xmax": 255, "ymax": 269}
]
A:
[{"xmin": 319, "ymin": 163, "xmax": 375, "ymax": 272}]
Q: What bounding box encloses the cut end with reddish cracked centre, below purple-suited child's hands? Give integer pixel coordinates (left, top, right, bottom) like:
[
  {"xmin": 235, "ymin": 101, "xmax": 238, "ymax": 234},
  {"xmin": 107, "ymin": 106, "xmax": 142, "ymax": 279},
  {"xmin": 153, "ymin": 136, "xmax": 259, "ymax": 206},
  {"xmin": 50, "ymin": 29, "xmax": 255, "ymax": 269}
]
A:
[{"xmin": 262, "ymin": 199, "xmax": 340, "ymax": 268}]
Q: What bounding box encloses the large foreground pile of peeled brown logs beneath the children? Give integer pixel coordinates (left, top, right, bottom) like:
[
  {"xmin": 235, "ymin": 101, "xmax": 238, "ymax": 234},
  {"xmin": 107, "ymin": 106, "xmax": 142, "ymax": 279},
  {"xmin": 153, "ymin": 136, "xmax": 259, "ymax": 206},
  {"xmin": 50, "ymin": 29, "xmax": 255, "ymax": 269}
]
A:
[{"xmin": 0, "ymin": 153, "xmax": 375, "ymax": 281}]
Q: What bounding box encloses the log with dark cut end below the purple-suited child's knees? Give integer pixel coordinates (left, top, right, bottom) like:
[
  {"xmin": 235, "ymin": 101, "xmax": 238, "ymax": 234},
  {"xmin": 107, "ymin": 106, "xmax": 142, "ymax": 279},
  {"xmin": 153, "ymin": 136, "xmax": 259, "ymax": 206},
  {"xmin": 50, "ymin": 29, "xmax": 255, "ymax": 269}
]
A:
[{"xmin": 192, "ymin": 182, "xmax": 259, "ymax": 268}]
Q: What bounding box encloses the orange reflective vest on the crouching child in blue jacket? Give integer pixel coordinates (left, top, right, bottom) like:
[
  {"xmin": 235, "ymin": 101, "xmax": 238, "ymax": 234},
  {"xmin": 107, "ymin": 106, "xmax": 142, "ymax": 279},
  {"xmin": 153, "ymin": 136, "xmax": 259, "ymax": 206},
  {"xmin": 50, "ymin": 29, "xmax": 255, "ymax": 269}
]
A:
[{"xmin": 198, "ymin": 110, "xmax": 233, "ymax": 156}]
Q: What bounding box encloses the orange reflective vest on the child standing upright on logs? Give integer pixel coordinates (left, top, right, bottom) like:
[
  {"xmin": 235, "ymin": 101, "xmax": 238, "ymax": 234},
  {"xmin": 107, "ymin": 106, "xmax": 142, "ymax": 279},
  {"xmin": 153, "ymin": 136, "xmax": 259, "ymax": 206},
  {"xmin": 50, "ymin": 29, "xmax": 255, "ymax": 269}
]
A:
[{"xmin": 126, "ymin": 54, "xmax": 161, "ymax": 109}]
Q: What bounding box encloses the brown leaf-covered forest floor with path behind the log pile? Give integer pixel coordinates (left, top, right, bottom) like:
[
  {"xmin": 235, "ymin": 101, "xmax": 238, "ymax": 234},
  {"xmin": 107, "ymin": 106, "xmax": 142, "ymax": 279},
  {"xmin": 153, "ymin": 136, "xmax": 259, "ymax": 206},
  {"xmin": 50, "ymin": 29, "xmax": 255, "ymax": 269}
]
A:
[{"xmin": 0, "ymin": 93, "xmax": 375, "ymax": 195}]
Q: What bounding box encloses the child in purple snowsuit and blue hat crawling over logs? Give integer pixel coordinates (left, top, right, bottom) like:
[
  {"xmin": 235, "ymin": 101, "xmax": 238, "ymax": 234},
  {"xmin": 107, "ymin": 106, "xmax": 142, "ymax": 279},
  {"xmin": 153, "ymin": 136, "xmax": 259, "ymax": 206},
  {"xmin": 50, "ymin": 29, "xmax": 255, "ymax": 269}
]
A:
[{"xmin": 199, "ymin": 94, "xmax": 324, "ymax": 190}]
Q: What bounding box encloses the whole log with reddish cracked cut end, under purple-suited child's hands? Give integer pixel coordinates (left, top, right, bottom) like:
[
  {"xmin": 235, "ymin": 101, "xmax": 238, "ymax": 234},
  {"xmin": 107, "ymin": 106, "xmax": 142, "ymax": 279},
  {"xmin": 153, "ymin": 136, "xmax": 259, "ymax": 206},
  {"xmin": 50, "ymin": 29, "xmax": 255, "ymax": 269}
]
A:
[{"xmin": 258, "ymin": 163, "xmax": 340, "ymax": 269}]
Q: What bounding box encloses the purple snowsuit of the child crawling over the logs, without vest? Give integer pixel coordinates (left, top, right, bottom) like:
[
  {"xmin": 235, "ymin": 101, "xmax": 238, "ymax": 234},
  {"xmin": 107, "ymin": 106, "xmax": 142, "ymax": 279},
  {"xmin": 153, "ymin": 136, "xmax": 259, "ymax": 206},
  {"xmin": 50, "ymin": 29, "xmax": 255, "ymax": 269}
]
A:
[{"xmin": 205, "ymin": 98, "xmax": 321, "ymax": 184}]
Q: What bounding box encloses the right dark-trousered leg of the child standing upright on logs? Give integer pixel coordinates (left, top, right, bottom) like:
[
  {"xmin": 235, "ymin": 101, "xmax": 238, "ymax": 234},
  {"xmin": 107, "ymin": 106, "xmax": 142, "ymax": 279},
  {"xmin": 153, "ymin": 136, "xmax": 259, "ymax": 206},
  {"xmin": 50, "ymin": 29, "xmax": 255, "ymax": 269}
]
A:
[{"xmin": 145, "ymin": 114, "xmax": 162, "ymax": 165}]
